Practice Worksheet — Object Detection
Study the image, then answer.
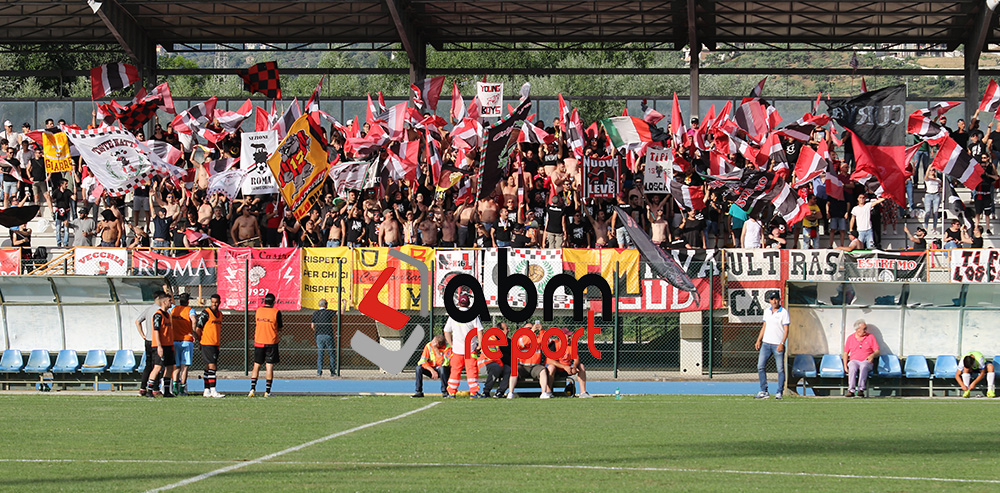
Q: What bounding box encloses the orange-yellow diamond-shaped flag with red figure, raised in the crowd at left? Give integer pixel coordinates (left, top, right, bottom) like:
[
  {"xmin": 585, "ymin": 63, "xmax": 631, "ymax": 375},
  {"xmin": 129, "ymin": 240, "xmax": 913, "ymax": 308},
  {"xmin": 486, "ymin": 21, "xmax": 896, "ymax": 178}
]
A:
[{"xmin": 267, "ymin": 115, "xmax": 330, "ymax": 220}]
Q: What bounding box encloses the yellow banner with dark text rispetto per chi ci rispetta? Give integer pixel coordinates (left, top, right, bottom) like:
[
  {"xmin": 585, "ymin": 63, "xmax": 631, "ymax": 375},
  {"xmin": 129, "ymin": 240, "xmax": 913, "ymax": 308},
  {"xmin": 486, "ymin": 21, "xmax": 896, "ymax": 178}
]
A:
[{"xmin": 302, "ymin": 247, "xmax": 354, "ymax": 310}]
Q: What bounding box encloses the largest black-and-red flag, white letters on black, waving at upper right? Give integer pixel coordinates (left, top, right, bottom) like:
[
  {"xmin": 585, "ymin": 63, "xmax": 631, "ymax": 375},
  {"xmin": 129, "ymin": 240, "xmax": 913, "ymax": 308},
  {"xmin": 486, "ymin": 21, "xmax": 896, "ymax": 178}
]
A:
[{"xmin": 827, "ymin": 85, "xmax": 907, "ymax": 185}]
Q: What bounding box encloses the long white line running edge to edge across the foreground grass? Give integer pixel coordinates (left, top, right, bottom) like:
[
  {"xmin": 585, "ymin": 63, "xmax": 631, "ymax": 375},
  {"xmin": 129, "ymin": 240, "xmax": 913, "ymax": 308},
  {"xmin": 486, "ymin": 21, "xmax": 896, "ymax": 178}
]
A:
[{"xmin": 0, "ymin": 456, "xmax": 1000, "ymax": 491}]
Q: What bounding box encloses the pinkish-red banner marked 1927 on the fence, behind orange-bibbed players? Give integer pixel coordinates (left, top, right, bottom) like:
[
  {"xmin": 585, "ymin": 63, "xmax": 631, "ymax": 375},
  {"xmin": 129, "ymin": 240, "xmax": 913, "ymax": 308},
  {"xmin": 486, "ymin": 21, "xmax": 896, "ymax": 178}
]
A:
[{"xmin": 218, "ymin": 248, "xmax": 302, "ymax": 310}]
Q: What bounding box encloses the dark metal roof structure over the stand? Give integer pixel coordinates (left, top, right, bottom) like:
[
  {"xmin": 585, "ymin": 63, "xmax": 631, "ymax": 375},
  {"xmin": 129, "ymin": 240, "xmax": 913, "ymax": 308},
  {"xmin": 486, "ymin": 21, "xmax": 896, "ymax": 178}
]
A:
[{"xmin": 0, "ymin": 0, "xmax": 1000, "ymax": 110}]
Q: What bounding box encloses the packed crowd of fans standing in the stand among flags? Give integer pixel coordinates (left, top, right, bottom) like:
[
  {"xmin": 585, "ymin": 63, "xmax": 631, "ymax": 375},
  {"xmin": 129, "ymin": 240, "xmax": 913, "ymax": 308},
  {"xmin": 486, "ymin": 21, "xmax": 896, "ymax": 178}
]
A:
[{"xmin": 0, "ymin": 106, "xmax": 1000, "ymax": 254}]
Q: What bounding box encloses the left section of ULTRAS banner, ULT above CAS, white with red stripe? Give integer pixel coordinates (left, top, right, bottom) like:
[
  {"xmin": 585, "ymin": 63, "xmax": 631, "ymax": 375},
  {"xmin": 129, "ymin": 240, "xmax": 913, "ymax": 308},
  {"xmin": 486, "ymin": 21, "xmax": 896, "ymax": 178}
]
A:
[{"xmin": 726, "ymin": 249, "xmax": 784, "ymax": 323}]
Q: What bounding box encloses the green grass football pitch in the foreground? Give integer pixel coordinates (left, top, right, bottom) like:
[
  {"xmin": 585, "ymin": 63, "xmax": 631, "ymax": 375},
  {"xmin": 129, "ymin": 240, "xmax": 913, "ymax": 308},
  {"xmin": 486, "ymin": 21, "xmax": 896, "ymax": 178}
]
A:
[{"xmin": 0, "ymin": 394, "xmax": 1000, "ymax": 492}]
